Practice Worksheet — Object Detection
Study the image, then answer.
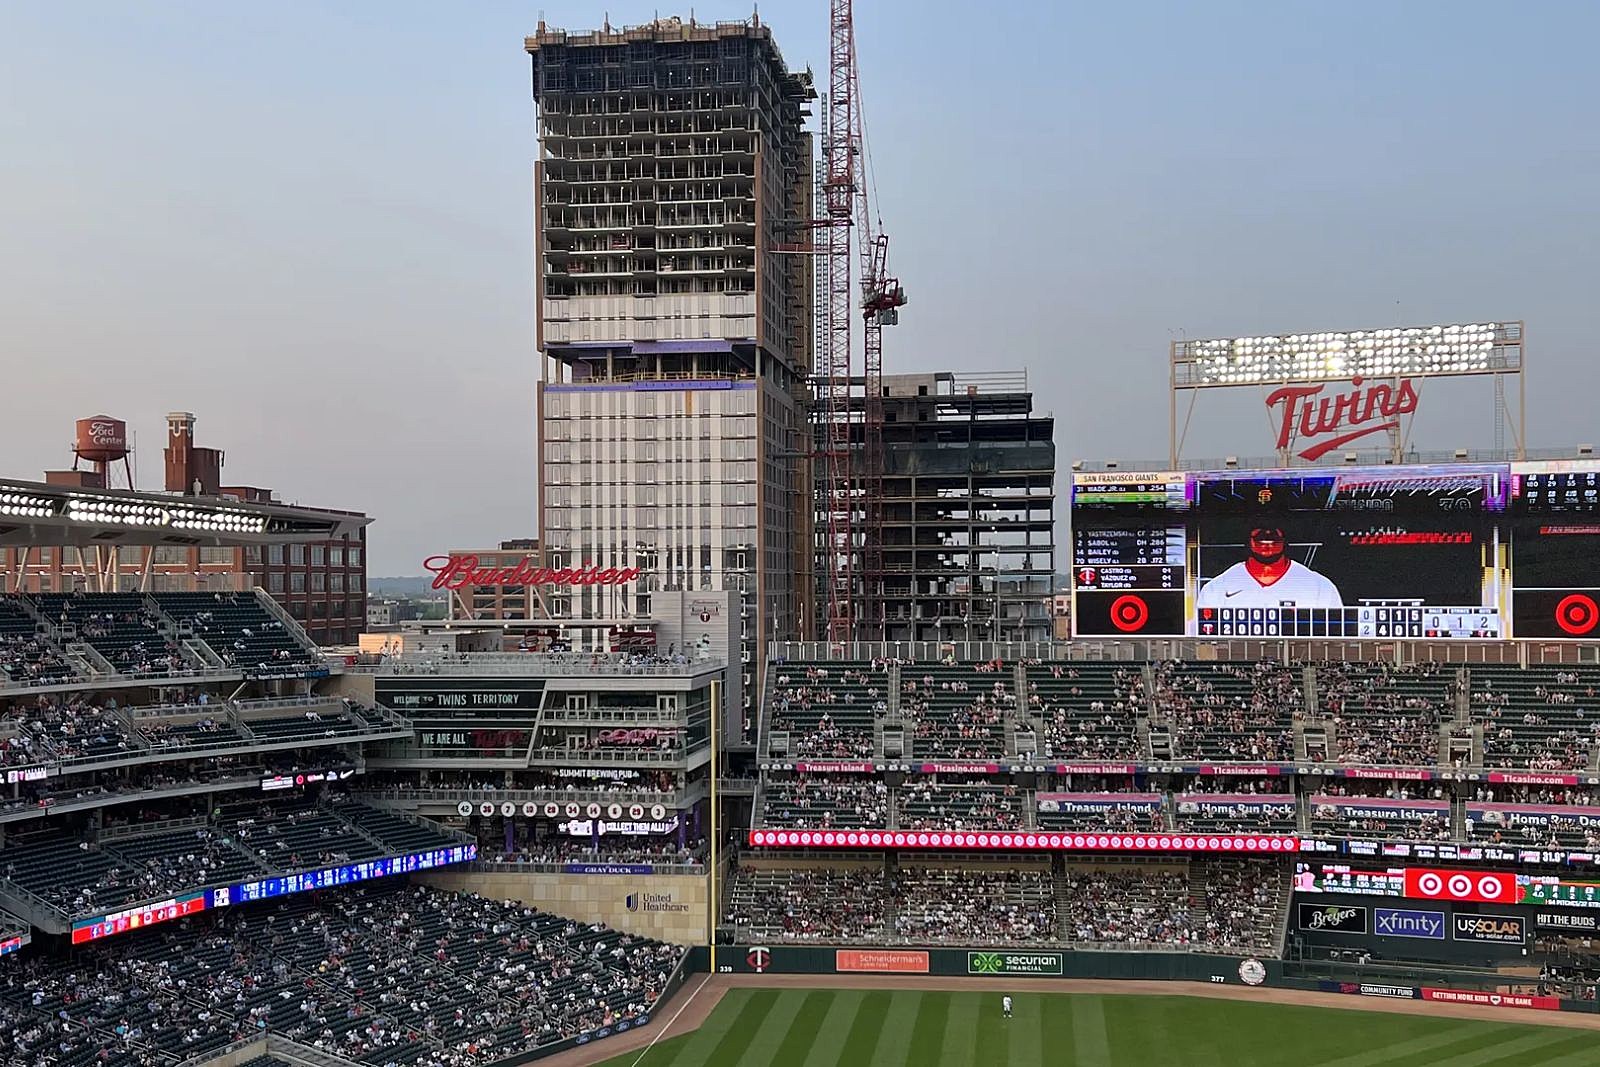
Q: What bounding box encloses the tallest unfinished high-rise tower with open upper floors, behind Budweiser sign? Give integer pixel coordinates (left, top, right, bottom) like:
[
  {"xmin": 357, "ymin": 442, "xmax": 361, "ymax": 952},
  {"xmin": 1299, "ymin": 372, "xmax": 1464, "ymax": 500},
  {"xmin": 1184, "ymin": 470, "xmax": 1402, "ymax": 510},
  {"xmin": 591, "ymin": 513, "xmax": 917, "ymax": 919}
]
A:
[{"xmin": 526, "ymin": 19, "xmax": 816, "ymax": 723}]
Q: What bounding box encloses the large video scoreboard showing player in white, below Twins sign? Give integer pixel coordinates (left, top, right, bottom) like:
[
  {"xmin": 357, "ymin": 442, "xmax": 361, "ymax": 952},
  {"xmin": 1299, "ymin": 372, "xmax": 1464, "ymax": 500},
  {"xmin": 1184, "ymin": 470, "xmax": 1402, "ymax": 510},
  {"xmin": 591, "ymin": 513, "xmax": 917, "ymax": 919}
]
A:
[{"xmin": 1072, "ymin": 461, "xmax": 1600, "ymax": 640}]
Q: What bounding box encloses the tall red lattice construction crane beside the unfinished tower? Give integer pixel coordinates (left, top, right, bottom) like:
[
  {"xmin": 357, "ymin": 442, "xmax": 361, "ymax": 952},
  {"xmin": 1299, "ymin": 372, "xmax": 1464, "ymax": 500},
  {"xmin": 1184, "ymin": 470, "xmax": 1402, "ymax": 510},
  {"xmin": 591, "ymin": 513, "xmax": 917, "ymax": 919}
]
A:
[{"xmin": 818, "ymin": 0, "xmax": 906, "ymax": 645}]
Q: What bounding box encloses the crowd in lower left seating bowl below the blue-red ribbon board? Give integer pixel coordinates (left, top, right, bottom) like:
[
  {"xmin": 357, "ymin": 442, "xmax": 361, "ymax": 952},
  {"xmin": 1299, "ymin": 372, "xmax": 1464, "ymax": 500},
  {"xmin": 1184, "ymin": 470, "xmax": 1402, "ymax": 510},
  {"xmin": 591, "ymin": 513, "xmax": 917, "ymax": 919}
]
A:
[{"xmin": 0, "ymin": 885, "xmax": 682, "ymax": 1067}]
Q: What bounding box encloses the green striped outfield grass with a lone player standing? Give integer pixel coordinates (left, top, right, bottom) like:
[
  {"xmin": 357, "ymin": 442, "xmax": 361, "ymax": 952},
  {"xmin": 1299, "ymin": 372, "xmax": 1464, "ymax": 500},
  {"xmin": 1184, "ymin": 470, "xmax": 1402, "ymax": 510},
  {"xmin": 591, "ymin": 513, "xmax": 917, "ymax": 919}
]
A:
[{"xmin": 605, "ymin": 985, "xmax": 1600, "ymax": 1067}]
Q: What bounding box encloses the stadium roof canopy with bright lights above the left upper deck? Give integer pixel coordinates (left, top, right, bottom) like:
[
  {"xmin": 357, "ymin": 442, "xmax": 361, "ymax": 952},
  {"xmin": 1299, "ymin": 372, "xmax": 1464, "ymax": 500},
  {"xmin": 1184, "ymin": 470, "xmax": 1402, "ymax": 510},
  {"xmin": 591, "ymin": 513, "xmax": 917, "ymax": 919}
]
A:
[{"xmin": 0, "ymin": 478, "xmax": 371, "ymax": 547}]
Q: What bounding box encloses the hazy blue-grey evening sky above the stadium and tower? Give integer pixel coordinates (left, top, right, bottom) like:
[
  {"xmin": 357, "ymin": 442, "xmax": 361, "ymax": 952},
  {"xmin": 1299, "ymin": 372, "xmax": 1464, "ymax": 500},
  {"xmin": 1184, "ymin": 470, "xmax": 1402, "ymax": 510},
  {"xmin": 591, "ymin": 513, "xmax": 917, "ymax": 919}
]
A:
[{"xmin": 0, "ymin": 0, "xmax": 1600, "ymax": 576}]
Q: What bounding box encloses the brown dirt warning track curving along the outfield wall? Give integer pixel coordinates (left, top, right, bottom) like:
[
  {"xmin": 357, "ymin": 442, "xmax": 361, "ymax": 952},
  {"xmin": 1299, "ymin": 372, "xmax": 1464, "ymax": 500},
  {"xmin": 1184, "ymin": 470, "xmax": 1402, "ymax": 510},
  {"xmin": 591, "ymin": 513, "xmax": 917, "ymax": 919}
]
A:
[{"xmin": 538, "ymin": 974, "xmax": 1600, "ymax": 1067}]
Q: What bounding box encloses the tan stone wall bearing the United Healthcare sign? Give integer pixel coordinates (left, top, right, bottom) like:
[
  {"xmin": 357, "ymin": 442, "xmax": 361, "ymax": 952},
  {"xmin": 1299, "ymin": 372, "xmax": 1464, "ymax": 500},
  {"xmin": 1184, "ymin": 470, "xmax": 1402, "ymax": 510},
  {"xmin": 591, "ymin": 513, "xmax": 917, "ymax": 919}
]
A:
[{"xmin": 418, "ymin": 864, "xmax": 710, "ymax": 945}]
